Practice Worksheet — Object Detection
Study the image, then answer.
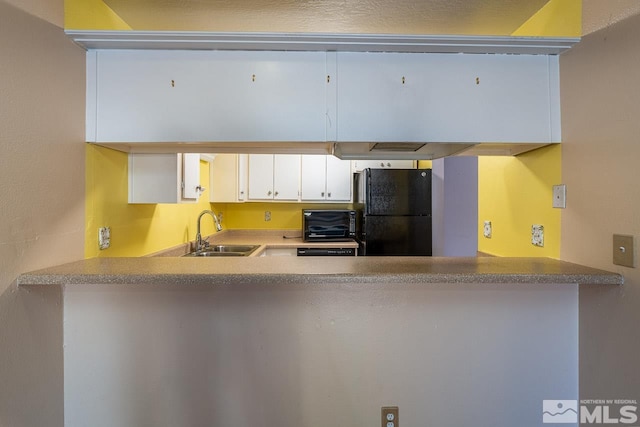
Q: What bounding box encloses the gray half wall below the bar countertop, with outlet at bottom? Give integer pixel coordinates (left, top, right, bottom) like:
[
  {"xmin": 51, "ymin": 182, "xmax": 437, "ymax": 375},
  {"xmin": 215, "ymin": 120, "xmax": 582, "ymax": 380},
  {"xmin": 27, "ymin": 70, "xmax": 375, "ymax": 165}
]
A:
[{"xmin": 64, "ymin": 282, "xmax": 578, "ymax": 427}]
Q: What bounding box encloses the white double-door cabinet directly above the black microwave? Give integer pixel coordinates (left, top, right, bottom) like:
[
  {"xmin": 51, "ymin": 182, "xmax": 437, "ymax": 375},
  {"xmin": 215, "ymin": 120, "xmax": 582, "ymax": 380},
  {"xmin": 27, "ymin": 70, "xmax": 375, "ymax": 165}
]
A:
[{"xmin": 301, "ymin": 155, "xmax": 351, "ymax": 202}]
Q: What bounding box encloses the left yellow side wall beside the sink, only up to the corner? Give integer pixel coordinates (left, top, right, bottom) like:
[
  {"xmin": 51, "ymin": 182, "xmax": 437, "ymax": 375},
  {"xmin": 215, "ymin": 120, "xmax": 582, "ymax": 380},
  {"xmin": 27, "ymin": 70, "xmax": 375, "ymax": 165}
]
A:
[{"xmin": 85, "ymin": 144, "xmax": 217, "ymax": 258}]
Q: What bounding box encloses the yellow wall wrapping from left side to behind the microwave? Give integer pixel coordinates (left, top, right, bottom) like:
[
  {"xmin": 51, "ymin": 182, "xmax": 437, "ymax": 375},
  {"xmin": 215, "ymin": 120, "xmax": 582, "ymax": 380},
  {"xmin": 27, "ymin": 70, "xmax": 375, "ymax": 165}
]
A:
[{"xmin": 85, "ymin": 144, "xmax": 350, "ymax": 258}]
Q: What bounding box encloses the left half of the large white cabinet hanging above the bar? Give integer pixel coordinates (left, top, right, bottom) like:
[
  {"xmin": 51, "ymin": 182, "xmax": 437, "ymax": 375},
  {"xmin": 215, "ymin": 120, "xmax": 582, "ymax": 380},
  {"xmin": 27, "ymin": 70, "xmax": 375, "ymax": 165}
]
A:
[{"xmin": 87, "ymin": 50, "xmax": 327, "ymax": 142}]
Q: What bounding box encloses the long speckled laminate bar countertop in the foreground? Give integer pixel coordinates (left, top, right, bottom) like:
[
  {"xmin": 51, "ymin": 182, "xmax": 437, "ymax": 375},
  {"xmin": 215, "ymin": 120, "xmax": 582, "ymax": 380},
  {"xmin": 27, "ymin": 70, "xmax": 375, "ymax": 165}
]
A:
[{"xmin": 18, "ymin": 257, "xmax": 624, "ymax": 286}]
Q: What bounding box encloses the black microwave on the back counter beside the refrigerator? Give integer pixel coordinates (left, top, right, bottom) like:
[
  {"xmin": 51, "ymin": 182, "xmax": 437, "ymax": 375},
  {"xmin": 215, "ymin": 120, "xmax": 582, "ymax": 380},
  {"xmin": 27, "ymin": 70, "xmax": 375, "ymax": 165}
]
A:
[{"xmin": 302, "ymin": 209, "xmax": 356, "ymax": 242}]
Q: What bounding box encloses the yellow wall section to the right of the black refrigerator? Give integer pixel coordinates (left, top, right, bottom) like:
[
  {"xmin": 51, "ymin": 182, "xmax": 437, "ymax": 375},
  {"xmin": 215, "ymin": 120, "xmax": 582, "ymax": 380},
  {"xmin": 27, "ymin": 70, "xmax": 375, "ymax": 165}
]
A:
[{"xmin": 478, "ymin": 145, "xmax": 562, "ymax": 258}]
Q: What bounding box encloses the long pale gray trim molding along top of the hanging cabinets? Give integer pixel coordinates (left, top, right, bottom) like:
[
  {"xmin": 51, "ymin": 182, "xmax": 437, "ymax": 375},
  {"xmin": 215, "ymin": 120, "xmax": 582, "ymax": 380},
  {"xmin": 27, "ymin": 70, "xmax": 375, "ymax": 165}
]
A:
[{"xmin": 65, "ymin": 30, "xmax": 580, "ymax": 55}]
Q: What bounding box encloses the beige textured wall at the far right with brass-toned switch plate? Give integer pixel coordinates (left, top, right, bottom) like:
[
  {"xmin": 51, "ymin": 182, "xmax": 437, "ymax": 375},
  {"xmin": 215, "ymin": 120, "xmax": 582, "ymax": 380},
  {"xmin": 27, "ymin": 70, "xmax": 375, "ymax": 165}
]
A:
[{"xmin": 560, "ymin": 11, "xmax": 640, "ymax": 408}]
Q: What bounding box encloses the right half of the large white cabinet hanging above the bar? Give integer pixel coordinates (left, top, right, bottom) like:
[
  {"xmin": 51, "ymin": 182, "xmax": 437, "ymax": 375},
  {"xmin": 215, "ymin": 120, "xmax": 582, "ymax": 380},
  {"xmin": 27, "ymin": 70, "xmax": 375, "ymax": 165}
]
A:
[{"xmin": 337, "ymin": 52, "xmax": 559, "ymax": 142}]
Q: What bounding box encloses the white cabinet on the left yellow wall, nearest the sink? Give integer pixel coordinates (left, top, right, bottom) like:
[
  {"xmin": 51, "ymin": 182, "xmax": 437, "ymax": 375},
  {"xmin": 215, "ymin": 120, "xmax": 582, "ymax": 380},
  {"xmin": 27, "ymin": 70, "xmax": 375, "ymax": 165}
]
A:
[{"xmin": 128, "ymin": 154, "xmax": 200, "ymax": 203}]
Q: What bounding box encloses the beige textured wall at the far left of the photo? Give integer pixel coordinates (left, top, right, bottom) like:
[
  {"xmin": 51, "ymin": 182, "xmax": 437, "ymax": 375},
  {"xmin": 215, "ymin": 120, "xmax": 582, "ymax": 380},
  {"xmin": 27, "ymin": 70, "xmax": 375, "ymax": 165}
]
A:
[{"xmin": 0, "ymin": 1, "xmax": 85, "ymax": 427}]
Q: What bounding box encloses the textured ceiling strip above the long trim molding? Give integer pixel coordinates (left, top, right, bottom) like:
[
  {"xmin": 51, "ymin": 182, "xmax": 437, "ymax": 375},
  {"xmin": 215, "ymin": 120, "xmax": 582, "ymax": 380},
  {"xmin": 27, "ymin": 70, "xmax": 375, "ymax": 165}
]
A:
[{"xmin": 105, "ymin": 0, "xmax": 552, "ymax": 35}]
